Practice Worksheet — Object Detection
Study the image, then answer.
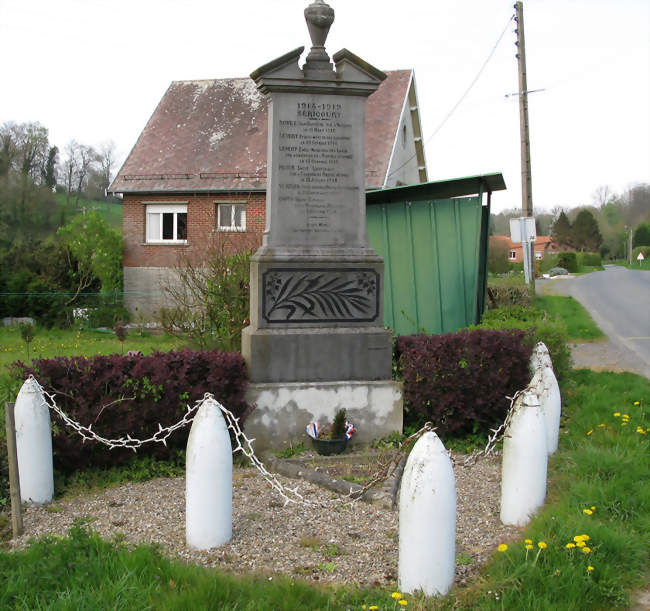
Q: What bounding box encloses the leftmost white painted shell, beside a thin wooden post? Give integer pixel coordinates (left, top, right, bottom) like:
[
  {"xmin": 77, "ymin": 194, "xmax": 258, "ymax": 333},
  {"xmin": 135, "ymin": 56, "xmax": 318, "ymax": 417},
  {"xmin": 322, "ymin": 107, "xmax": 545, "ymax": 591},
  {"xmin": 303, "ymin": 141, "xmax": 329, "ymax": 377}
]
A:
[{"xmin": 14, "ymin": 378, "xmax": 54, "ymax": 505}]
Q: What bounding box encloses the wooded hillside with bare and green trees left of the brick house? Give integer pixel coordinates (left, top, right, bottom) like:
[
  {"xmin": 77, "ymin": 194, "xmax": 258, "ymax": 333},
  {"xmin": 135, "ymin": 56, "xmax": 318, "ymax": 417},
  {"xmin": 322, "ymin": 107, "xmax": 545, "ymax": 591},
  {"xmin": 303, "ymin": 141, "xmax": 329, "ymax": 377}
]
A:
[{"xmin": 0, "ymin": 122, "xmax": 124, "ymax": 324}]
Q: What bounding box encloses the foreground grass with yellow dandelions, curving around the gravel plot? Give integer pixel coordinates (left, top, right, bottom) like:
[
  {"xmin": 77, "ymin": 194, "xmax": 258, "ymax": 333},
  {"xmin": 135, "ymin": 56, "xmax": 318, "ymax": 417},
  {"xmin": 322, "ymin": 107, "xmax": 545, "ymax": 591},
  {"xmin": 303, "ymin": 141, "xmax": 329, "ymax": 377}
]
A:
[{"xmin": 0, "ymin": 370, "xmax": 650, "ymax": 611}]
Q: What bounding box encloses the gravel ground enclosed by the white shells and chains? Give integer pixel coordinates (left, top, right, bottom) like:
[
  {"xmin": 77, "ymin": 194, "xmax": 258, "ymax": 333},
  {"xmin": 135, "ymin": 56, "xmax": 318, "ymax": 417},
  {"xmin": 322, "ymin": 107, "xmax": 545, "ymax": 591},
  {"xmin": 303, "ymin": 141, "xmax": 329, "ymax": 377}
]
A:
[{"xmin": 11, "ymin": 450, "xmax": 519, "ymax": 585}]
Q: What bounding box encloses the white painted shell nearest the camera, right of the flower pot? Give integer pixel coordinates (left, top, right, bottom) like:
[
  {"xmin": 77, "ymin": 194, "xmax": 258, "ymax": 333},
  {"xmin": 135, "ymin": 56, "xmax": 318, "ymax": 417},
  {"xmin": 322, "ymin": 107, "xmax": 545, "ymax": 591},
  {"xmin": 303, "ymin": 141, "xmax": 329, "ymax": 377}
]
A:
[{"xmin": 398, "ymin": 432, "xmax": 456, "ymax": 596}]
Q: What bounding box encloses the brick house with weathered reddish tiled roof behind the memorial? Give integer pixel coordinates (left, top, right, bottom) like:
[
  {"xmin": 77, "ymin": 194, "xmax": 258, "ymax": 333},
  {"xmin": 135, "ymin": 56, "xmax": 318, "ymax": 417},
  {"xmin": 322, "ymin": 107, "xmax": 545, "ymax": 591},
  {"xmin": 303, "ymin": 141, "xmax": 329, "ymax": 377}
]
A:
[{"xmin": 109, "ymin": 70, "xmax": 427, "ymax": 316}]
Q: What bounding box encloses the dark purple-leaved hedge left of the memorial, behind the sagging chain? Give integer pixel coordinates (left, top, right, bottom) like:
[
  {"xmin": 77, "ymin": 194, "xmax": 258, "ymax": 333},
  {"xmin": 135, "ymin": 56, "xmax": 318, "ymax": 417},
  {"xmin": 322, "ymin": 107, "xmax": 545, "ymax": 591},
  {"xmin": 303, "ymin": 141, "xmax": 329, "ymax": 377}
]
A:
[{"xmin": 14, "ymin": 350, "xmax": 251, "ymax": 471}]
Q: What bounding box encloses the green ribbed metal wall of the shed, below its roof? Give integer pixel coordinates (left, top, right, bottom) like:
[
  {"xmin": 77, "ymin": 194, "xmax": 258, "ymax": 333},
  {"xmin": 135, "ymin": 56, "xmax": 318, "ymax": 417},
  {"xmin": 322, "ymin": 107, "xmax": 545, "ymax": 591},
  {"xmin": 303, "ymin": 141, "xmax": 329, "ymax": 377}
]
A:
[{"xmin": 366, "ymin": 197, "xmax": 481, "ymax": 335}]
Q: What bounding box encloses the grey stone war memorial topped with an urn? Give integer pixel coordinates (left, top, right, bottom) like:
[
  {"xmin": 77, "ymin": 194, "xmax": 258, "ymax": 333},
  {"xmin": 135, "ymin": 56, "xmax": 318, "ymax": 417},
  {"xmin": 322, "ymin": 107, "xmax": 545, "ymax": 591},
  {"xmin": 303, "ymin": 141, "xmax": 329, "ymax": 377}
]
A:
[{"xmin": 242, "ymin": 0, "xmax": 402, "ymax": 448}]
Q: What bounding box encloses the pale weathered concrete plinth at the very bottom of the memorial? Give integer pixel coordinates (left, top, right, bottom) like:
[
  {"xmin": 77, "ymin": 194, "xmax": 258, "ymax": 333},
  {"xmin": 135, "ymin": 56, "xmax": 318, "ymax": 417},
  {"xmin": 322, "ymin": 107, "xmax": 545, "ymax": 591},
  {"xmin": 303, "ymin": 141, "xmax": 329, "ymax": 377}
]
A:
[{"xmin": 246, "ymin": 380, "xmax": 403, "ymax": 452}]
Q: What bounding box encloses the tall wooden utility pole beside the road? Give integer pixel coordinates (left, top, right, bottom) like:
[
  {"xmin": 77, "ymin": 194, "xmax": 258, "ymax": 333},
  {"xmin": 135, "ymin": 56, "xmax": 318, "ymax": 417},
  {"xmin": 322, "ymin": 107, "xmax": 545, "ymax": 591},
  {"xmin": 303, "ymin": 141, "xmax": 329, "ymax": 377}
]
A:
[{"xmin": 515, "ymin": 2, "xmax": 535, "ymax": 294}]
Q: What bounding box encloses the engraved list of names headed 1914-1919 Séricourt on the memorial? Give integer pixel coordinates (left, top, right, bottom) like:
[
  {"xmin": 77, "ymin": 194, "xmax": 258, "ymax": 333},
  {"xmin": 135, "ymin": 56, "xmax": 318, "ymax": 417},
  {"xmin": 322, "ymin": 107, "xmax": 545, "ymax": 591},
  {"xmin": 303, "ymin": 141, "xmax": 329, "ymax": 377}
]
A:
[{"xmin": 274, "ymin": 95, "xmax": 363, "ymax": 245}]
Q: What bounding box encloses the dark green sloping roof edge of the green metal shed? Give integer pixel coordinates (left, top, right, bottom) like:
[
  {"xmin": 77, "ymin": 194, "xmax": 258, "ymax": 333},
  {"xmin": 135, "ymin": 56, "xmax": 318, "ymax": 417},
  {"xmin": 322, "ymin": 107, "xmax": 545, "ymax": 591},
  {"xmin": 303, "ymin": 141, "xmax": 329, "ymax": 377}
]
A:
[{"xmin": 366, "ymin": 172, "xmax": 506, "ymax": 205}]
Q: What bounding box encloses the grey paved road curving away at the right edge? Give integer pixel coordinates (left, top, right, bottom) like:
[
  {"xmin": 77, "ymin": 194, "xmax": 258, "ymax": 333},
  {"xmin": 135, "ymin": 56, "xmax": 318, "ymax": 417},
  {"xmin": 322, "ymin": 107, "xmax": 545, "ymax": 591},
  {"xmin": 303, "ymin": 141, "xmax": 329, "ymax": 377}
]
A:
[{"xmin": 542, "ymin": 265, "xmax": 650, "ymax": 377}]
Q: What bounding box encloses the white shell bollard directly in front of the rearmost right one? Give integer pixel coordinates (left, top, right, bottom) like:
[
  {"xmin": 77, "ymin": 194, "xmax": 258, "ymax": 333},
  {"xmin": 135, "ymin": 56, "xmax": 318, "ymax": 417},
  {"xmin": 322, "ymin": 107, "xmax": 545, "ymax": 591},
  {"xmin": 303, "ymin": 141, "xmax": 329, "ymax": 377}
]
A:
[{"xmin": 501, "ymin": 392, "xmax": 548, "ymax": 526}]
